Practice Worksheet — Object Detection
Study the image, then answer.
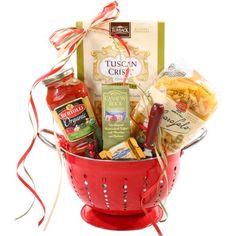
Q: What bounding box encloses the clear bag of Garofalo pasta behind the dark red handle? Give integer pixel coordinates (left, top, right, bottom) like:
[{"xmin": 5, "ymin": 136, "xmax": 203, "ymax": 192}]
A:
[{"xmin": 132, "ymin": 64, "xmax": 217, "ymax": 154}]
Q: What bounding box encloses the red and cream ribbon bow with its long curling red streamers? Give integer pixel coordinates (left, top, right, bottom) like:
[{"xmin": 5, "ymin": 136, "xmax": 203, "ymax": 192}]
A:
[{"xmin": 16, "ymin": 1, "xmax": 130, "ymax": 226}]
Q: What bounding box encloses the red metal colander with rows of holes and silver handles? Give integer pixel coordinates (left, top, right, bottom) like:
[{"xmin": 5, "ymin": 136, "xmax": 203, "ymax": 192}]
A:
[{"xmin": 39, "ymin": 129, "xmax": 206, "ymax": 230}]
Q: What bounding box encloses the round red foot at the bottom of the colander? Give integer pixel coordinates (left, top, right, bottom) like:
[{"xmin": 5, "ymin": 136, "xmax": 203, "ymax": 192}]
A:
[{"xmin": 81, "ymin": 205, "xmax": 163, "ymax": 230}]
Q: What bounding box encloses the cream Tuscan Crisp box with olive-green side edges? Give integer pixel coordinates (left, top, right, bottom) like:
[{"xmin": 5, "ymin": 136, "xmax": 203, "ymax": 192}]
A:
[{"xmin": 76, "ymin": 22, "xmax": 165, "ymax": 124}]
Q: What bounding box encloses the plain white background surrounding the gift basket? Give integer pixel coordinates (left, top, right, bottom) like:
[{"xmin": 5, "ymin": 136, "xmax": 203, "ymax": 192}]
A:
[{"xmin": 0, "ymin": 0, "xmax": 236, "ymax": 236}]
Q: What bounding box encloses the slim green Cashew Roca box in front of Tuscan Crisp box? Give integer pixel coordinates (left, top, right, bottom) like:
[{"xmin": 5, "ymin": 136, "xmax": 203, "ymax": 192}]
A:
[{"xmin": 102, "ymin": 85, "xmax": 130, "ymax": 149}]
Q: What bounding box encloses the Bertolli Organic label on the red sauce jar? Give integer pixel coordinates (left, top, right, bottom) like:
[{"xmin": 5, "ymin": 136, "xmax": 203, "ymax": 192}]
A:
[{"xmin": 53, "ymin": 97, "xmax": 96, "ymax": 142}]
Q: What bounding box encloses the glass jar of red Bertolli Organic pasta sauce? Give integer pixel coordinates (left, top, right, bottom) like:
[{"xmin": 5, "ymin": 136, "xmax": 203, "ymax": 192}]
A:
[{"xmin": 43, "ymin": 68, "xmax": 98, "ymax": 157}]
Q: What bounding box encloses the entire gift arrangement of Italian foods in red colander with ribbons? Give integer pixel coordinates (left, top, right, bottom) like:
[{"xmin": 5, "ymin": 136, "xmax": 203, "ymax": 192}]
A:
[{"xmin": 17, "ymin": 2, "xmax": 217, "ymax": 235}]
